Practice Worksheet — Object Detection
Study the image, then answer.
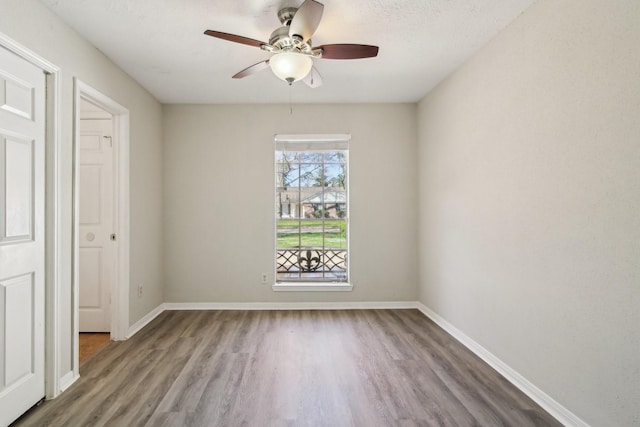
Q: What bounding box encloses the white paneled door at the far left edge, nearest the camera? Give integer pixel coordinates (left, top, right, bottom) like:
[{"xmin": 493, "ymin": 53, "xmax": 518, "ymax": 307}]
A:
[{"xmin": 0, "ymin": 48, "xmax": 45, "ymax": 425}]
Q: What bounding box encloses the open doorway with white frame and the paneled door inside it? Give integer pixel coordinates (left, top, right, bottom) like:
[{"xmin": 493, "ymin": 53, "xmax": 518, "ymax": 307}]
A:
[{"xmin": 73, "ymin": 79, "xmax": 129, "ymax": 374}]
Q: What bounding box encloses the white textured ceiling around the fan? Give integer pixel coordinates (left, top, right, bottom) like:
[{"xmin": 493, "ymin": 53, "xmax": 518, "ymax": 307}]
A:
[{"xmin": 41, "ymin": 0, "xmax": 535, "ymax": 104}]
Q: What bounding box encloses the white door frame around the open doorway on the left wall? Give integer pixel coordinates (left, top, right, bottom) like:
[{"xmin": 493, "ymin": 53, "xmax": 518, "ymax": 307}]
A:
[{"xmin": 73, "ymin": 78, "xmax": 129, "ymax": 375}]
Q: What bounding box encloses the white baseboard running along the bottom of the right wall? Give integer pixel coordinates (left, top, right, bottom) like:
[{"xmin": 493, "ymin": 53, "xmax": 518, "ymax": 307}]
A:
[{"xmin": 417, "ymin": 302, "xmax": 589, "ymax": 427}]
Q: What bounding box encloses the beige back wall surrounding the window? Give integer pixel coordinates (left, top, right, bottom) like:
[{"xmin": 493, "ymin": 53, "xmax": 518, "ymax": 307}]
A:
[{"xmin": 164, "ymin": 103, "xmax": 417, "ymax": 302}]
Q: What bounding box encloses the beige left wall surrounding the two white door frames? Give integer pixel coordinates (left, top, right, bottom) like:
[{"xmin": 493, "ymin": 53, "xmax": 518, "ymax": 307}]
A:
[{"xmin": 0, "ymin": 0, "xmax": 163, "ymax": 382}]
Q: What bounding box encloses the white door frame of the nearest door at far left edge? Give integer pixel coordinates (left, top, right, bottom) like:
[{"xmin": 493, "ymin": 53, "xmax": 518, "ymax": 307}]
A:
[{"xmin": 0, "ymin": 33, "xmax": 63, "ymax": 399}]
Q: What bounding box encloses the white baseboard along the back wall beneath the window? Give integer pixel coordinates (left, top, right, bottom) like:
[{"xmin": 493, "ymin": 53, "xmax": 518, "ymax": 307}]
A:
[{"xmin": 163, "ymin": 301, "xmax": 416, "ymax": 310}]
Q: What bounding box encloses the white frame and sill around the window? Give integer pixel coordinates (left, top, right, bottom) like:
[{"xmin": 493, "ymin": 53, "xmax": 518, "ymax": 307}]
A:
[{"xmin": 272, "ymin": 134, "xmax": 353, "ymax": 292}]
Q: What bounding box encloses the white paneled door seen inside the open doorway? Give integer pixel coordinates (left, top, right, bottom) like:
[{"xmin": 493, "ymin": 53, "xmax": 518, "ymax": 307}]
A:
[{"xmin": 79, "ymin": 116, "xmax": 115, "ymax": 332}]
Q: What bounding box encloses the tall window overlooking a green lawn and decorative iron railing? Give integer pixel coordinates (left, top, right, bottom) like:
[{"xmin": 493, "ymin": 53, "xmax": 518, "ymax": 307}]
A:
[{"xmin": 275, "ymin": 135, "xmax": 349, "ymax": 285}]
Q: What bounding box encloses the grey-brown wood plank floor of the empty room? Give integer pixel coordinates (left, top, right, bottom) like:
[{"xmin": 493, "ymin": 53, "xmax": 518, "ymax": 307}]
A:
[{"xmin": 16, "ymin": 310, "xmax": 560, "ymax": 427}]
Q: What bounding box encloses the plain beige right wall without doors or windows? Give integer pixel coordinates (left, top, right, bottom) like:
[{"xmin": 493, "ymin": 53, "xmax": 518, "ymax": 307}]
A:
[{"xmin": 418, "ymin": 0, "xmax": 640, "ymax": 426}]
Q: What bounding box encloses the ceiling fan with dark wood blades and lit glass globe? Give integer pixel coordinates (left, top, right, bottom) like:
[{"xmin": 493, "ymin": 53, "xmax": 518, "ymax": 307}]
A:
[{"xmin": 204, "ymin": 0, "xmax": 378, "ymax": 88}]
